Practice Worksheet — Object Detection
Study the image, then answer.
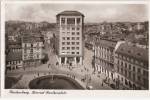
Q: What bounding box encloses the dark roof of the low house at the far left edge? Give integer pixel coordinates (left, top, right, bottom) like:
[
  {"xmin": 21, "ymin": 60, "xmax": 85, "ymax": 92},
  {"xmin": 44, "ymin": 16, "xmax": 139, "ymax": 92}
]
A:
[{"xmin": 6, "ymin": 50, "xmax": 22, "ymax": 61}]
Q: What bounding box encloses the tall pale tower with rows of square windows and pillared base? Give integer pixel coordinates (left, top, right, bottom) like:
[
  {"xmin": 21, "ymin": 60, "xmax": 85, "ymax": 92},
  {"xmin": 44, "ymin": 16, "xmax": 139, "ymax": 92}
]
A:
[{"xmin": 56, "ymin": 11, "xmax": 84, "ymax": 65}]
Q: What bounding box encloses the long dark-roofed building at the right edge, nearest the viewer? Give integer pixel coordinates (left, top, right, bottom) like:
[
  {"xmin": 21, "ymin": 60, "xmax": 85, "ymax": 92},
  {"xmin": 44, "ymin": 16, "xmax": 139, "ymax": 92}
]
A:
[{"xmin": 114, "ymin": 43, "xmax": 149, "ymax": 89}]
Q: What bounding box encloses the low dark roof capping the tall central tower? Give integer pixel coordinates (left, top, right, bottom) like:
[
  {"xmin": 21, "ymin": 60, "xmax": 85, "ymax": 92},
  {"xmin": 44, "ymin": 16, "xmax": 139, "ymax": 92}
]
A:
[{"xmin": 56, "ymin": 10, "xmax": 84, "ymax": 17}]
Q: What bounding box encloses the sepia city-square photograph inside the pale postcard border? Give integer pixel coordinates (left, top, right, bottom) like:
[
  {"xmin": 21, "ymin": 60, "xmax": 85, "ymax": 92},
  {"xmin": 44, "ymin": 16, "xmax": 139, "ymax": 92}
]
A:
[{"xmin": 3, "ymin": 2, "xmax": 149, "ymax": 91}]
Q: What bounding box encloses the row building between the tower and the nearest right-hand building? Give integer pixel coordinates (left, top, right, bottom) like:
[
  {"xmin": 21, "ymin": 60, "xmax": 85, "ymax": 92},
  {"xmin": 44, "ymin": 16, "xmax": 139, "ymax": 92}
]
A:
[{"xmin": 94, "ymin": 40, "xmax": 117, "ymax": 79}]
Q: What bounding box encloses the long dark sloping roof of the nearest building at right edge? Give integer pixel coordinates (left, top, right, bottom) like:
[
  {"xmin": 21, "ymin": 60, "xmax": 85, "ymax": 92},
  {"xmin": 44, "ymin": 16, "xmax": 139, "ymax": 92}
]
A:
[{"xmin": 116, "ymin": 43, "xmax": 148, "ymax": 62}]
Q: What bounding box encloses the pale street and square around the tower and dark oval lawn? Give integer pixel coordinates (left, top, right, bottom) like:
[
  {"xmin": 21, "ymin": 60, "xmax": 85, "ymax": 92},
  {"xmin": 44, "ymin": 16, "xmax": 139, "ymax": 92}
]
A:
[{"xmin": 7, "ymin": 42, "xmax": 112, "ymax": 90}]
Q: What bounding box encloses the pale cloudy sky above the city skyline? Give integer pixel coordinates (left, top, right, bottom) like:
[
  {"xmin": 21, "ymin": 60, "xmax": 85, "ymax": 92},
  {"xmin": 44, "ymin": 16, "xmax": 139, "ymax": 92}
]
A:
[{"xmin": 5, "ymin": 4, "xmax": 148, "ymax": 22}]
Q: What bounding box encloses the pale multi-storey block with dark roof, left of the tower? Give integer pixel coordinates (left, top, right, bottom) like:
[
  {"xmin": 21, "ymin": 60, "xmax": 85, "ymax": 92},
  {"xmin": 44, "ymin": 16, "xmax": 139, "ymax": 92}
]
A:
[{"xmin": 22, "ymin": 35, "xmax": 44, "ymax": 67}]
